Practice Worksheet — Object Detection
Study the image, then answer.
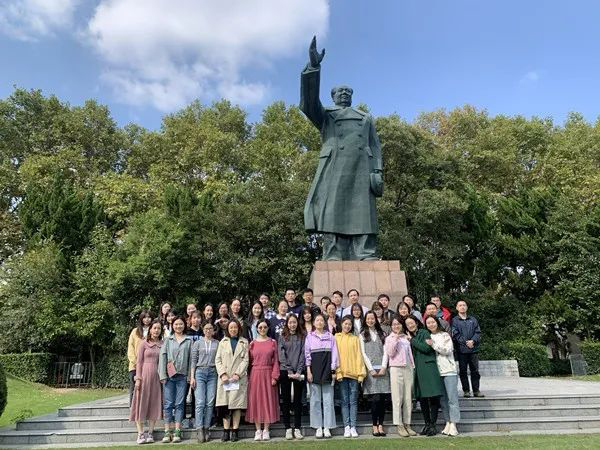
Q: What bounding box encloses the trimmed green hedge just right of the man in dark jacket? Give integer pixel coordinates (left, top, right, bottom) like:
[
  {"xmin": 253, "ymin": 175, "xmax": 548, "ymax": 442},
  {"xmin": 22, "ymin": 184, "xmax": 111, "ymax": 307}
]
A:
[{"xmin": 479, "ymin": 342, "xmax": 551, "ymax": 377}]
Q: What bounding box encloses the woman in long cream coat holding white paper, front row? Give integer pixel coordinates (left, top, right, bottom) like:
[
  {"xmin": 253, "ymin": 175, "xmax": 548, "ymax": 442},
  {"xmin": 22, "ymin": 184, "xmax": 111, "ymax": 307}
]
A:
[{"xmin": 215, "ymin": 319, "xmax": 248, "ymax": 442}]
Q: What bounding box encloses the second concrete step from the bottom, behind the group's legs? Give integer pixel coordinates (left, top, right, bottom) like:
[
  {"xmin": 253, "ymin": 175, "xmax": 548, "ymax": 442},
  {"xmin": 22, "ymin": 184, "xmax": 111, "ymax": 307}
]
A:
[{"xmin": 16, "ymin": 404, "xmax": 600, "ymax": 430}]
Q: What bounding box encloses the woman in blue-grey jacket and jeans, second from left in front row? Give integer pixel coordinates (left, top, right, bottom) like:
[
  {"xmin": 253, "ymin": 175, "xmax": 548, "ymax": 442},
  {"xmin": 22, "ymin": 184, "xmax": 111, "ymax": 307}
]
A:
[{"xmin": 158, "ymin": 316, "xmax": 192, "ymax": 443}]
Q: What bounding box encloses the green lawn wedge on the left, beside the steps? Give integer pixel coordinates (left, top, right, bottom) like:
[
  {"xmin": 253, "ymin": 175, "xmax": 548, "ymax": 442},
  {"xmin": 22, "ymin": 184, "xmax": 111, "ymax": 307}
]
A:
[{"xmin": 0, "ymin": 375, "xmax": 126, "ymax": 427}]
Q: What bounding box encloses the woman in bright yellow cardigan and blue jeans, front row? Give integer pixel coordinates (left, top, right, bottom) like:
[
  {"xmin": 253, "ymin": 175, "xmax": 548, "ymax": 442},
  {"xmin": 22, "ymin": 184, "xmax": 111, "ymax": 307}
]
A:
[{"xmin": 335, "ymin": 316, "xmax": 367, "ymax": 437}]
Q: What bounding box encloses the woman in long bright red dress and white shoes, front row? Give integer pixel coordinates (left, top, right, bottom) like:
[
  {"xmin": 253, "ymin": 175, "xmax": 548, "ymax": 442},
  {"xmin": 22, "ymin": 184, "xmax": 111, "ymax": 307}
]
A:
[{"xmin": 246, "ymin": 319, "xmax": 279, "ymax": 441}]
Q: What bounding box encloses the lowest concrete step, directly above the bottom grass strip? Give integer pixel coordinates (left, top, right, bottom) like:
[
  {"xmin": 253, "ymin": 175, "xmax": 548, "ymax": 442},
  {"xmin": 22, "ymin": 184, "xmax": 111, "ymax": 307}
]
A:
[{"xmin": 0, "ymin": 416, "xmax": 600, "ymax": 446}]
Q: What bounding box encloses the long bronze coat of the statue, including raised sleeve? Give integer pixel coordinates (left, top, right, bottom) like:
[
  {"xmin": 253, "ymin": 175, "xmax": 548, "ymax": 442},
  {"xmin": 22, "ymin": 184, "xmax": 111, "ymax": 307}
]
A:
[{"xmin": 300, "ymin": 67, "xmax": 383, "ymax": 235}]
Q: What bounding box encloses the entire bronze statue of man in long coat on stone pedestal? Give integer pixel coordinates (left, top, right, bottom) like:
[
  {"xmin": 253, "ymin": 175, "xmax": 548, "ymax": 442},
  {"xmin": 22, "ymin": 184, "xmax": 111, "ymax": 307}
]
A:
[{"xmin": 300, "ymin": 37, "xmax": 383, "ymax": 261}]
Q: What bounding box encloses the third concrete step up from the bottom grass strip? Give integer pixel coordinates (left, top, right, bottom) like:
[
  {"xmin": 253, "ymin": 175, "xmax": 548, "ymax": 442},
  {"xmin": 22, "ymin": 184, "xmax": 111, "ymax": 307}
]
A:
[{"xmin": 58, "ymin": 394, "xmax": 600, "ymax": 417}]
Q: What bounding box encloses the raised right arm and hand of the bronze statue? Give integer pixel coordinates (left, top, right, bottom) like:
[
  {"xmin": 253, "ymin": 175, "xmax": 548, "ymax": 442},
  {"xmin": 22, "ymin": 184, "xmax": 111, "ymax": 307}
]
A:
[{"xmin": 300, "ymin": 36, "xmax": 325, "ymax": 130}]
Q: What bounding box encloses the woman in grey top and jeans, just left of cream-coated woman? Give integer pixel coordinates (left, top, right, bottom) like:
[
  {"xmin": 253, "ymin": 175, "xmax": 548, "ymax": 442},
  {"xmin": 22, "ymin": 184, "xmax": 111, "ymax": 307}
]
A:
[{"xmin": 190, "ymin": 322, "xmax": 219, "ymax": 442}]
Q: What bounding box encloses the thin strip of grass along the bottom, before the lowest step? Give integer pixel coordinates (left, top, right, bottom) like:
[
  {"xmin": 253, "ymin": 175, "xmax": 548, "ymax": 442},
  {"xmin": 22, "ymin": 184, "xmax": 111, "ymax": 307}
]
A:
[{"xmin": 54, "ymin": 434, "xmax": 600, "ymax": 450}]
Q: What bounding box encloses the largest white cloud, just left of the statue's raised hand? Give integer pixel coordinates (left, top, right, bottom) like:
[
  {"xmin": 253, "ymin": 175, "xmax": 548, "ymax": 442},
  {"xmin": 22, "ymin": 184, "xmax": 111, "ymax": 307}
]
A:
[{"xmin": 87, "ymin": 0, "xmax": 329, "ymax": 111}]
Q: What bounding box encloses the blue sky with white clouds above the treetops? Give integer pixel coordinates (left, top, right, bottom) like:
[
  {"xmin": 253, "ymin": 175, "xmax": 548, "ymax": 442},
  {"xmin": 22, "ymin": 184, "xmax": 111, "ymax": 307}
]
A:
[{"xmin": 0, "ymin": 0, "xmax": 600, "ymax": 129}]
